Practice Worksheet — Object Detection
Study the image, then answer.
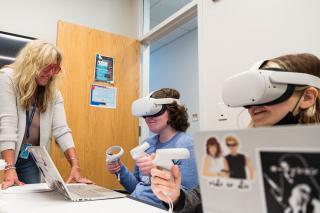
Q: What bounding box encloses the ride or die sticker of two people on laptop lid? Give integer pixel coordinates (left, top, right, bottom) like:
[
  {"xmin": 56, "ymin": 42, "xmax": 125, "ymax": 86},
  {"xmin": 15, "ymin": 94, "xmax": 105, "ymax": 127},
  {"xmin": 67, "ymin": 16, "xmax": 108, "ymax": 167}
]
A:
[{"xmin": 201, "ymin": 135, "xmax": 255, "ymax": 191}]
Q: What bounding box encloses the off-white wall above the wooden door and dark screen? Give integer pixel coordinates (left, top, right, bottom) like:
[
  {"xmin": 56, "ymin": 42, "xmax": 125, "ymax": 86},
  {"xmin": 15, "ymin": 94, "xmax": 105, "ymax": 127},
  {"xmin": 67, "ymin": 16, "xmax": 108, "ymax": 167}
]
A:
[{"xmin": 0, "ymin": 0, "xmax": 139, "ymax": 43}]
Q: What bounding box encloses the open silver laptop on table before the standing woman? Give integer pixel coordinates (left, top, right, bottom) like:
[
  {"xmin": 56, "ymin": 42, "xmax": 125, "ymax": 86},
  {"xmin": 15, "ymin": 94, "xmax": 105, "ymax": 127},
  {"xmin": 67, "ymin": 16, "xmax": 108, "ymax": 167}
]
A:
[{"xmin": 28, "ymin": 146, "xmax": 126, "ymax": 201}]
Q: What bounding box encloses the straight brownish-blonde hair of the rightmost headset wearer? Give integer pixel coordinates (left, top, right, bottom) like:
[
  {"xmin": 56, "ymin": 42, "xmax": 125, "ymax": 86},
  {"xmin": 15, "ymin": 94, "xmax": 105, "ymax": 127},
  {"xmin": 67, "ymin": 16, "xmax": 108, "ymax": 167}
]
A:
[{"xmin": 261, "ymin": 53, "xmax": 320, "ymax": 124}]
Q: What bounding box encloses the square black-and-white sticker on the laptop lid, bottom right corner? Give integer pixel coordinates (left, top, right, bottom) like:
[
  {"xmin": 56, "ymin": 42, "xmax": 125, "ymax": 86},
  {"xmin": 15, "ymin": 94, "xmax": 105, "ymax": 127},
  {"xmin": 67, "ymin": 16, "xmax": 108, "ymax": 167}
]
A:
[{"xmin": 259, "ymin": 151, "xmax": 320, "ymax": 213}]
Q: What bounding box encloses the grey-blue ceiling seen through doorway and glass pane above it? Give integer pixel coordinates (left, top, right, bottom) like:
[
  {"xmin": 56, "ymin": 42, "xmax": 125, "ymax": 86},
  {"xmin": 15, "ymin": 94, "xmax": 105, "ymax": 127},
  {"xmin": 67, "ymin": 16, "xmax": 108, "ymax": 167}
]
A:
[{"xmin": 150, "ymin": 0, "xmax": 198, "ymax": 53}]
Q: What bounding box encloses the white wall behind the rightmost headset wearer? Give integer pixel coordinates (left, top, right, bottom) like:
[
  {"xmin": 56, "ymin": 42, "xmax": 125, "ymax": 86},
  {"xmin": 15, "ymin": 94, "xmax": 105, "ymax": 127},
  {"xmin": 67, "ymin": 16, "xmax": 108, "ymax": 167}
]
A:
[{"xmin": 198, "ymin": 0, "xmax": 320, "ymax": 130}]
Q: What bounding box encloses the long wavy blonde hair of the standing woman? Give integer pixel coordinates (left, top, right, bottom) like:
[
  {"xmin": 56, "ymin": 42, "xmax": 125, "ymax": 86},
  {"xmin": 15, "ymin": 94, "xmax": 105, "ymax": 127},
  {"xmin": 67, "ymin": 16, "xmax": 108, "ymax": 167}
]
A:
[{"xmin": 9, "ymin": 40, "xmax": 62, "ymax": 112}]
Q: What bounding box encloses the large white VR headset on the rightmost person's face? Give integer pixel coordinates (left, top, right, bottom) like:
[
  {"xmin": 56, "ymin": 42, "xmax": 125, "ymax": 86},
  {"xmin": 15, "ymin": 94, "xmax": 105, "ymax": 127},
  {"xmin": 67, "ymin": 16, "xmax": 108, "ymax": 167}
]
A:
[{"xmin": 222, "ymin": 61, "xmax": 320, "ymax": 108}]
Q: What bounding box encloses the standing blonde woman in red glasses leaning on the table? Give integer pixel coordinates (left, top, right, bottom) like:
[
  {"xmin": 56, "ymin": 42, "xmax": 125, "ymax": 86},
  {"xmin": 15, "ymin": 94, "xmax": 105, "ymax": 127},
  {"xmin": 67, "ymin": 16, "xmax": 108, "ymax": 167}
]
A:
[{"xmin": 0, "ymin": 40, "xmax": 92, "ymax": 189}]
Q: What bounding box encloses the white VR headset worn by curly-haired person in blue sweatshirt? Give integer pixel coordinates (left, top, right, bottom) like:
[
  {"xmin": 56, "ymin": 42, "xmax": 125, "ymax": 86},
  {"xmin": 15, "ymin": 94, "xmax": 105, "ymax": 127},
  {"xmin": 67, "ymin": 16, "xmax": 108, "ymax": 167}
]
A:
[{"xmin": 131, "ymin": 92, "xmax": 181, "ymax": 117}]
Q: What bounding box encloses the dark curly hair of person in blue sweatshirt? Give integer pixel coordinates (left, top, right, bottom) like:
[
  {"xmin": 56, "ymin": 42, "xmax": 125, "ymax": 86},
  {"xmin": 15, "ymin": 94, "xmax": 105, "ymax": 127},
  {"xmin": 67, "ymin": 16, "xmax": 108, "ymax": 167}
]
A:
[{"xmin": 151, "ymin": 88, "xmax": 190, "ymax": 132}]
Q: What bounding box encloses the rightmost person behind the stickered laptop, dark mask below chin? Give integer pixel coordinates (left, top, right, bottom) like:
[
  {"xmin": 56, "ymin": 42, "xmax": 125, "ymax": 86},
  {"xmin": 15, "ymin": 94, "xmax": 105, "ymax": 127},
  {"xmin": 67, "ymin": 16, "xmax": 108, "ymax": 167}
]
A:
[{"xmin": 151, "ymin": 54, "xmax": 320, "ymax": 212}]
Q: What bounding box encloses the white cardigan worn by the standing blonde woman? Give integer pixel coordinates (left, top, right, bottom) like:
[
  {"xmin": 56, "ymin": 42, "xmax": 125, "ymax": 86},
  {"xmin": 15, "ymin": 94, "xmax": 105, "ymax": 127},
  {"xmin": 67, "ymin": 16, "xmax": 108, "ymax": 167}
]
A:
[{"xmin": 0, "ymin": 68, "xmax": 74, "ymax": 159}]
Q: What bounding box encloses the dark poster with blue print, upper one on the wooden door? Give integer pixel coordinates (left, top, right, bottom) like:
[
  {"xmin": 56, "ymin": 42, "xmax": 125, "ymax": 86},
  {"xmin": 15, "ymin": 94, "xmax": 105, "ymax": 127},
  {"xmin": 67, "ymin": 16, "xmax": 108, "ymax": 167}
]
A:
[{"xmin": 94, "ymin": 54, "xmax": 114, "ymax": 84}]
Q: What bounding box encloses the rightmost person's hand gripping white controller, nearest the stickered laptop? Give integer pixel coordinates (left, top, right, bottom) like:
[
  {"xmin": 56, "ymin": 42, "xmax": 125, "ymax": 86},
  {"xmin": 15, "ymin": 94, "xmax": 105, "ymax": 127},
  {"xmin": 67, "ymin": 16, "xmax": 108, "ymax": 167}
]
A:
[{"xmin": 151, "ymin": 165, "xmax": 181, "ymax": 203}]
